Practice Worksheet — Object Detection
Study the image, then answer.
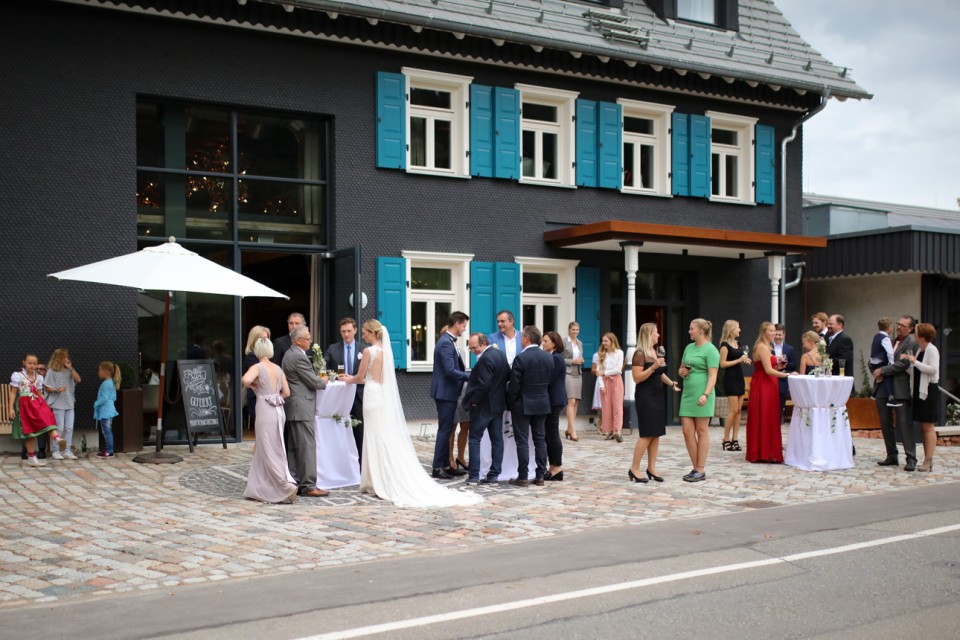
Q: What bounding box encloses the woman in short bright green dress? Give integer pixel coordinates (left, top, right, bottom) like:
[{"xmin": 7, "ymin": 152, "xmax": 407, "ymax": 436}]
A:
[{"xmin": 678, "ymin": 318, "xmax": 720, "ymax": 482}]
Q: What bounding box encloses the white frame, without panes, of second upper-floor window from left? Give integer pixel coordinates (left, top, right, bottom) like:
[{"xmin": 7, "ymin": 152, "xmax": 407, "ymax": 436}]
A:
[{"xmin": 514, "ymin": 84, "xmax": 580, "ymax": 187}]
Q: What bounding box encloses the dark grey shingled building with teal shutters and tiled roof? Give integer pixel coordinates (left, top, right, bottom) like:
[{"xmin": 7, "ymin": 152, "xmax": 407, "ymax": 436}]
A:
[{"xmin": 0, "ymin": 0, "xmax": 869, "ymax": 444}]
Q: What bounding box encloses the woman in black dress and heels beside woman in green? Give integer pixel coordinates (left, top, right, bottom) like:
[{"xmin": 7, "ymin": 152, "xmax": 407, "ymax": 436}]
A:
[{"xmin": 627, "ymin": 322, "xmax": 680, "ymax": 482}]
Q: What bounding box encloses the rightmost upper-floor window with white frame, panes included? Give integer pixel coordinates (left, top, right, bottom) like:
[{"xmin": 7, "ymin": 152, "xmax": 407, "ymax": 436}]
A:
[{"xmin": 706, "ymin": 111, "xmax": 757, "ymax": 202}]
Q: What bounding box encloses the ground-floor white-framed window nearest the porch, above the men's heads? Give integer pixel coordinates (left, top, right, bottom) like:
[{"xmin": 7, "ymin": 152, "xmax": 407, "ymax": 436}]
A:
[{"xmin": 516, "ymin": 257, "xmax": 580, "ymax": 335}]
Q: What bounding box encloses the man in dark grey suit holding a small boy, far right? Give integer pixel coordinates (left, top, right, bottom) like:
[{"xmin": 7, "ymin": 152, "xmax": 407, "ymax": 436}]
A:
[{"xmin": 873, "ymin": 316, "xmax": 917, "ymax": 471}]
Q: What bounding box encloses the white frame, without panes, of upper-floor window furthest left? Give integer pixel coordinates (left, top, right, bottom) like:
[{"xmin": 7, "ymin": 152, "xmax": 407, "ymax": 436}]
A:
[{"xmin": 401, "ymin": 67, "xmax": 473, "ymax": 178}]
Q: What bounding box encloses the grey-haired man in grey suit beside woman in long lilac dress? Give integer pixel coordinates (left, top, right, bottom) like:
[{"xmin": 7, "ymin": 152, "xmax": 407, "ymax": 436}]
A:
[{"xmin": 283, "ymin": 326, "xmax": 329, "ymax": 498}]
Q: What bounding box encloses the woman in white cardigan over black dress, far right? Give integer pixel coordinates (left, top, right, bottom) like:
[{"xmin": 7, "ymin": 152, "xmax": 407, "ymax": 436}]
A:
[{"xmin": 900, "ymin": 322, "xmax": 940, "ymax": 471}]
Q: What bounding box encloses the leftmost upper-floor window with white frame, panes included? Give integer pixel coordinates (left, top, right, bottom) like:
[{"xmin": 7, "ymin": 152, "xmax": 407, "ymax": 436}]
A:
[{"xmin": 403, "ymin": 67, "xmax": 473, "ymax": 176}]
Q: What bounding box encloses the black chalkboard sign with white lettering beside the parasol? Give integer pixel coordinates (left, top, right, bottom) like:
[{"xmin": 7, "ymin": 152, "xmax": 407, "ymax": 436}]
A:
[{"xmin": 163, "ymin": 360, "xmax": 227, "ymax": 451}]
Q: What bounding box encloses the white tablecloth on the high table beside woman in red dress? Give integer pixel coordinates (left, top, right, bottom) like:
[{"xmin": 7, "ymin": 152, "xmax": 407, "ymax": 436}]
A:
[{"xmin": 784, "ymin": 376, "xmax": 854, "ymax": 471}]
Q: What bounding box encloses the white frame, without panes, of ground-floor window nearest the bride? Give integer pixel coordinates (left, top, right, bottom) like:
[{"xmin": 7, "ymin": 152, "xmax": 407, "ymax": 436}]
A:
[{"xmin": 400, "ymin": 251, "xmax": 473, "ymax": 371}]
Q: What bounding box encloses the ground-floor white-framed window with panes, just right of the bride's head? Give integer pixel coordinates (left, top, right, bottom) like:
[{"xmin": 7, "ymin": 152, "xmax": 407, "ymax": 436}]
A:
[{"xmin": 402, "ymin": 251, "xmax": 473, "ymax": 371}]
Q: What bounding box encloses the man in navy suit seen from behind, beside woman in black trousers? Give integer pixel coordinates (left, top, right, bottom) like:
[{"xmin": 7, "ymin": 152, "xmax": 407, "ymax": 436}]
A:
[{"xmin": 507, "ymin": 325, "xmax": 553, "ymax": 487}]
